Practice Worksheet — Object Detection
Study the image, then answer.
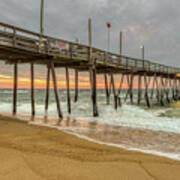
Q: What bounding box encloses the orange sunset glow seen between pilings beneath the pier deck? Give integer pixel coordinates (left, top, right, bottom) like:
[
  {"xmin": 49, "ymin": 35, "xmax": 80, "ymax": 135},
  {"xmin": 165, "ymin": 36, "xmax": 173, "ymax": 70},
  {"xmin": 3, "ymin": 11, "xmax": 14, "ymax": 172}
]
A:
[{"xmin": 0, "ymin": 71, "xmax": 150, "ymax": 88}]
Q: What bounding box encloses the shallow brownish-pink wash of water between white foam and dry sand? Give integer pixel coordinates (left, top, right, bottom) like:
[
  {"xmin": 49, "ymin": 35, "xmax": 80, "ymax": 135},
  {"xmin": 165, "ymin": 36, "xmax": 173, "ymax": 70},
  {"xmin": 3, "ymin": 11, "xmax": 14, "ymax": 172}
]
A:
[{"xmin": 1, "ymin": 111, "xmax": 180, "ymax": 160}]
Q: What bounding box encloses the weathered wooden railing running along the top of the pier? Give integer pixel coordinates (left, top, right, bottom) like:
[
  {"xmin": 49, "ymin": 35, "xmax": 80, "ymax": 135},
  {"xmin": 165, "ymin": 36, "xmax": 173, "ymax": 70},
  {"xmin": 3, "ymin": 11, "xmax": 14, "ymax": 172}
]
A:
[{"xmin": 0, "ymin": 22, "xmax": 180, "ymax": 74}]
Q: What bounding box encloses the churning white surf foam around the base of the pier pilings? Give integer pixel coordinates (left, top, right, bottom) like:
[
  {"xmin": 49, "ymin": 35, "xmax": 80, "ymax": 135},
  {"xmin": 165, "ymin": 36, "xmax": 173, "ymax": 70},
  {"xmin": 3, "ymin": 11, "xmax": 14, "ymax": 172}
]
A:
[{"xmin": 0, "ymin": 101, "xmax": 180, "ymax": 133}]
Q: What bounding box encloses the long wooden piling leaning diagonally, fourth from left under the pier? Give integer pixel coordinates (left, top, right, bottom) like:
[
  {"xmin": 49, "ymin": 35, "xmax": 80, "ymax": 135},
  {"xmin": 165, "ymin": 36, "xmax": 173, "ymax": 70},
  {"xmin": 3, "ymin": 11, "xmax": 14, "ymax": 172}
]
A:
[{"xmin": 50, "ymin": 62, "xmax": 63, "ymax": 119}]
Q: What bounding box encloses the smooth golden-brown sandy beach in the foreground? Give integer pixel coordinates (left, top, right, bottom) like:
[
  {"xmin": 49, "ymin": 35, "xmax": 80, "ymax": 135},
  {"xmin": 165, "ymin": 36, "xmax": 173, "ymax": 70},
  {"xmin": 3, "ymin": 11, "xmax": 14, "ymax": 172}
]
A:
[{"xmin": 0, "ymin": 116, "xmax": 180, "ymax": 180}]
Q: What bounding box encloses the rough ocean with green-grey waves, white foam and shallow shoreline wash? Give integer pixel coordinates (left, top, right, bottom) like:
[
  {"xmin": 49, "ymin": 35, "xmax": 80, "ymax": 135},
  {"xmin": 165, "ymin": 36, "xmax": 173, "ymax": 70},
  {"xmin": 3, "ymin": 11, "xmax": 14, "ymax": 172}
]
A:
[{"xmin": 0, "ymin": 89, "xmax": 180, "ymax": 160}]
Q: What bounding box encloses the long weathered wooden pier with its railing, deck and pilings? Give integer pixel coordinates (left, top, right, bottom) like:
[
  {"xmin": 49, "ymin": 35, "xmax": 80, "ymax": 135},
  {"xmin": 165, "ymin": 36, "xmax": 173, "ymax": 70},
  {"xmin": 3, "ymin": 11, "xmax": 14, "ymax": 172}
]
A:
[{"xmin": 0, "ymin": 22, "xmax": 180, "ymax": 119}]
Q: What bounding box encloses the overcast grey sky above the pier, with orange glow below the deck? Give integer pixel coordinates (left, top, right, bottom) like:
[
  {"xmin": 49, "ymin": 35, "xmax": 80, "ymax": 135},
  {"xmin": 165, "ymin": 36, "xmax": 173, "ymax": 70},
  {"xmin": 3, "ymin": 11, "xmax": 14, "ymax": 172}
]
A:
[{"xmin": 0, "ymin": 0, "xmax": 180, "ymax": 88}]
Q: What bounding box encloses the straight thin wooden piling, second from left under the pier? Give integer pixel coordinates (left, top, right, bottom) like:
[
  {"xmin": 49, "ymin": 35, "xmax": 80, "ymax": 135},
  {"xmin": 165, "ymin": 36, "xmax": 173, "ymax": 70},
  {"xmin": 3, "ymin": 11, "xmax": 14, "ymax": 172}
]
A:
[{"xmin": 31, "ymin": 63, "xmax": 35, "ymax": 116}]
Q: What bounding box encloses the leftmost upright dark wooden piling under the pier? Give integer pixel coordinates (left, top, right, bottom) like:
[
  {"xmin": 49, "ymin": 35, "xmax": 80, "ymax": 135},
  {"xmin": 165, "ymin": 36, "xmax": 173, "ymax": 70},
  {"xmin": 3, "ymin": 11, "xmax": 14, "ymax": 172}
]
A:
[{"xmin": 13, "ymin": 62, "xmax": 18, "ymax": 115}]
